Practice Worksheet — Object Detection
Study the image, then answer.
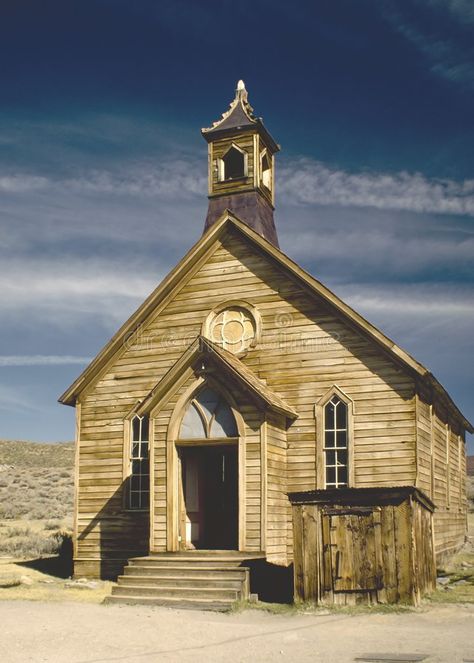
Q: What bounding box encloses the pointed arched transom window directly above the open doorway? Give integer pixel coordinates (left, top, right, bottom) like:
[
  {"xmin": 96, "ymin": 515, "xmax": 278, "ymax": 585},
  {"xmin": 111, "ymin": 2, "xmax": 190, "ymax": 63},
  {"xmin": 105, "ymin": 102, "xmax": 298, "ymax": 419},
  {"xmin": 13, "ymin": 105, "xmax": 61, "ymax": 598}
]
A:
[{"xmin": 179, "ymin": 387, "xmax": 238, "ymax": 440}]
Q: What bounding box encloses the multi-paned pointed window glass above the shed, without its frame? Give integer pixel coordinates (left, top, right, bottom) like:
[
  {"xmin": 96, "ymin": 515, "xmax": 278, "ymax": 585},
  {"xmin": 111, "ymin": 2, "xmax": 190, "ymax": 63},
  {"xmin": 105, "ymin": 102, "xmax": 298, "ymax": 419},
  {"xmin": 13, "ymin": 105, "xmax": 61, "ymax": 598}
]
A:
[{"xmin": 323, "ymin": 396, "xmax": 349, "ymax": 488}]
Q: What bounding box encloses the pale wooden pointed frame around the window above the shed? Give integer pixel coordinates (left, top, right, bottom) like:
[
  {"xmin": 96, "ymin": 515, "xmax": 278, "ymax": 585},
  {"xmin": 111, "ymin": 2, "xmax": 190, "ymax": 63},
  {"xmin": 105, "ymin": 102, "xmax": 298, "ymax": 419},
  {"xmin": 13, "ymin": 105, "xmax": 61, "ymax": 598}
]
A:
[{"xmin": 314, "ymin": 385, "xmax": 355, "ymax": 490}]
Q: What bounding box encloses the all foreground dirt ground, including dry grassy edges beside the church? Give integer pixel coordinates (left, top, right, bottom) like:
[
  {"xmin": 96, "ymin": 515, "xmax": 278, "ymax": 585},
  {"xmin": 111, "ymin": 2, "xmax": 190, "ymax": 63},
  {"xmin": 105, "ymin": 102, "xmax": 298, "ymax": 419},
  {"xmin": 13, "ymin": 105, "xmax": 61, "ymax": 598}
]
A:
[{"xmin": 0, "ymin": 512, "xmax": 474, "ymax": 663}]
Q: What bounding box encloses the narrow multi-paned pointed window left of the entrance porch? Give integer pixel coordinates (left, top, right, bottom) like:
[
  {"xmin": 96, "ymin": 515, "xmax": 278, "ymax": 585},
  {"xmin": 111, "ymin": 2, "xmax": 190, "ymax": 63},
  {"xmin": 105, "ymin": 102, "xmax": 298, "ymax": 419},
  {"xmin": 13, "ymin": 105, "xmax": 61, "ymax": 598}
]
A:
[{"xmin": 128, "ymin": 415, "xmax": 150, "ymax": 509}]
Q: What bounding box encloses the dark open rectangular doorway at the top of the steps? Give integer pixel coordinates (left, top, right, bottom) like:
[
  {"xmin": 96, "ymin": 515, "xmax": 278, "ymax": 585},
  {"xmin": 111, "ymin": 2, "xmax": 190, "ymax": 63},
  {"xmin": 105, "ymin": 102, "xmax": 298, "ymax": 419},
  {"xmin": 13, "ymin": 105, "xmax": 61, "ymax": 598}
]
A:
[{"xmin": 179, "ymin": 444, "xmax": 239, "ymax": 550}]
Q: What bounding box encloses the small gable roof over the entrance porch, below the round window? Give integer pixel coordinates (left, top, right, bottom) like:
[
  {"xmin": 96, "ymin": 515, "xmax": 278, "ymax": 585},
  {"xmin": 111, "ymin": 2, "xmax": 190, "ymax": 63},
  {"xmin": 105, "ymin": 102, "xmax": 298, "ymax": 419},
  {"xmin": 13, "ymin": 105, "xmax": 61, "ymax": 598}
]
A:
[{"xmin": 135, "ymin": 336, "xmax": 298, "ymax": 419}]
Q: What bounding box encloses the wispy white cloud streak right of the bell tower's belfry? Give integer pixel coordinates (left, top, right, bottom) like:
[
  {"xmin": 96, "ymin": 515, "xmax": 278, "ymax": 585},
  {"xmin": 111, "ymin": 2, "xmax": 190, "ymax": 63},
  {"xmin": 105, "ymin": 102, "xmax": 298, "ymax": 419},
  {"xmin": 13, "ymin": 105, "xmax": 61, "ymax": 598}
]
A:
[{"xmin": 278, "ymin": 158, "xmax": 474, "ymax": 216}]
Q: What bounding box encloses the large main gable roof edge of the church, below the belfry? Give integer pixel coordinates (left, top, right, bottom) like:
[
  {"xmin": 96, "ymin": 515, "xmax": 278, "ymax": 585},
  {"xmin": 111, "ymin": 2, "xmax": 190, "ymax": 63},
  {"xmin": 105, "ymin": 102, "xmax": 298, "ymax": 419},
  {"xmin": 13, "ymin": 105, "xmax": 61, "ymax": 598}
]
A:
[{"xmin": 59, "ymin": 210, "xmax": 474, "ymax": 433}]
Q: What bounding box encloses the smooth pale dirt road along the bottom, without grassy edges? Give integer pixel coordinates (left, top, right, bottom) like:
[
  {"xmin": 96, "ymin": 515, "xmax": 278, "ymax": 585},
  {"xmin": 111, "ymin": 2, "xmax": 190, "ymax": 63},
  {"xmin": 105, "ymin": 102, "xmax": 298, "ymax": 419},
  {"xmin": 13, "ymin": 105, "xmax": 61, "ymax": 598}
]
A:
[{"xmin": 0, "ymin": 601, "xmax": 474, "ymax": 663}]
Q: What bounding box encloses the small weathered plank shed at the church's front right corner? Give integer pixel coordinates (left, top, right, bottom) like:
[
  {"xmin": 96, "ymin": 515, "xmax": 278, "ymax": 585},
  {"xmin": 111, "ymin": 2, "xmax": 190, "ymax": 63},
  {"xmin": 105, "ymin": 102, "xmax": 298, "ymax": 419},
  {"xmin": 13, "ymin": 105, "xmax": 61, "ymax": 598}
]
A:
[{"xmin": 289, "ymin": 486, "xmax": 436, "ymax": 605}]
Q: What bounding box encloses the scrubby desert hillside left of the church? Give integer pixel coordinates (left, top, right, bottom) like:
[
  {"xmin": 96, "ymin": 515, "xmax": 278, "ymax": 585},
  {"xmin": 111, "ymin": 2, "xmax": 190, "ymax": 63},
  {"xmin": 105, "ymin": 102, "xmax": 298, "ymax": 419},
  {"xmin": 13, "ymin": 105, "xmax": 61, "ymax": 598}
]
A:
[{"xmin": 0, "ymin": 440, "xmax": 74, "ymax": 557}]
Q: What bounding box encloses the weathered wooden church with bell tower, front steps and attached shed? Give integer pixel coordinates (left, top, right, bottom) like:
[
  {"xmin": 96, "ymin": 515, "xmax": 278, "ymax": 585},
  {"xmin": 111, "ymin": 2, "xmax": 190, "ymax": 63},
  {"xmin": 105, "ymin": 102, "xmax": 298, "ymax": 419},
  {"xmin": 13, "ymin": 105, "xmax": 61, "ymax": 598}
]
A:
[{"xmin": 60, "ymin": 81, "xmax": 473, "ymax": 608}]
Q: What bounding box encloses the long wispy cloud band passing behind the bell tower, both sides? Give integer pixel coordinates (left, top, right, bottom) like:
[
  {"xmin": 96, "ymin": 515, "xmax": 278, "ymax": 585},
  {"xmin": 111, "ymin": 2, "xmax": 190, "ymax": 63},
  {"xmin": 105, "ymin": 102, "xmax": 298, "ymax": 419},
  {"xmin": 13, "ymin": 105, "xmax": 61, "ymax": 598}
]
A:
[{"xmin": 0, "ymin": 158, "xmax": 474, "ymax": 215}]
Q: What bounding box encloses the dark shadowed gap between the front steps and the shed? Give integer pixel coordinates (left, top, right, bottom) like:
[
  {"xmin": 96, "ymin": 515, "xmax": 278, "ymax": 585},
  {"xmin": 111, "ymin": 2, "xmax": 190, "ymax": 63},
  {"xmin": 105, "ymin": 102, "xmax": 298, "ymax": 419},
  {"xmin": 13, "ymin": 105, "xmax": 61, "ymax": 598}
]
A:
[{"xmin": 245, "ymin": 559, "xmax": 293, "ymax": 603}]
